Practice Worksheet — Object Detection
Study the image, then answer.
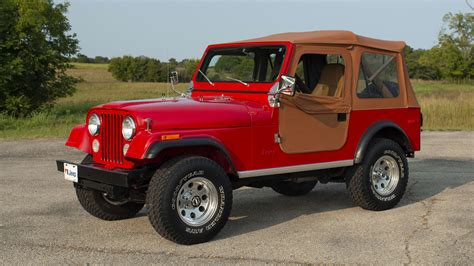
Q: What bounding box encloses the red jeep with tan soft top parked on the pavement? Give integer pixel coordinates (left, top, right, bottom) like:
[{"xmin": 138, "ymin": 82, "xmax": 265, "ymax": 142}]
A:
[{"xmin": 57, "ymin": 31, "xmax": 422, "ymax": 244}]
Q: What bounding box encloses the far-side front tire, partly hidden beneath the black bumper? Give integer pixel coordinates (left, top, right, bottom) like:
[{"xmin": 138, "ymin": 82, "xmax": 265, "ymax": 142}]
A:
[{"xmin": 76, "ymin": 186, "xmax": 144, "ymax": 221}]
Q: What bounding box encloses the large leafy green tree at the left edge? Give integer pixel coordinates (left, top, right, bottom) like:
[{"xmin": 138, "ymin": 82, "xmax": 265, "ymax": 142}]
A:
[{"xmin": 0, "ymin": 0, "xmax": 78, "ymax": 117}]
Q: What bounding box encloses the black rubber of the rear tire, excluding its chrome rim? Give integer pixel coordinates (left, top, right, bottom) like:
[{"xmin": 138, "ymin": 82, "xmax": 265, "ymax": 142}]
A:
[{"xmin": 346, "ymin": 138, "xmax": 408, "ymax": 211}]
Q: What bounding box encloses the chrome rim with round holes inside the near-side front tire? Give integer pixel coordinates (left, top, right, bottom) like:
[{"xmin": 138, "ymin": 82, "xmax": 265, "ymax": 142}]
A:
[{"xmin": 176, "ymin": 177, "xmax": 219, "ymax": 226}]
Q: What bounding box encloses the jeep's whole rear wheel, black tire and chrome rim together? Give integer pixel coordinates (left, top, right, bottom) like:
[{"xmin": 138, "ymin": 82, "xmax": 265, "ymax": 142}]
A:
[{"xmin": 346, "ymin": 139, "xmax": 408, "ymax": 211}]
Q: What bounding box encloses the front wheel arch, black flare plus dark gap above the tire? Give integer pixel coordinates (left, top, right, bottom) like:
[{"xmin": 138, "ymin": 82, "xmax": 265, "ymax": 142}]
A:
[{"xmin": 145, "ymin": 137, "xmax": 237, "ymax": 176}]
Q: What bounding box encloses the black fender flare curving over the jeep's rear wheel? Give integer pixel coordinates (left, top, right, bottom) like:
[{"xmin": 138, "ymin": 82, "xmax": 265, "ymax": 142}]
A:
[{"xmin": 354, "ymin": 120, "xmax": 413, "ymax": 164}]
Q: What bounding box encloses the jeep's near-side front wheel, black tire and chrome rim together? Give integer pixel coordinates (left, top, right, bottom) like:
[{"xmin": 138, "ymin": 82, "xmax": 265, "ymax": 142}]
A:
[{"xmin": 146, "ymin": 156, "xmax": 232, "ymax": 245}]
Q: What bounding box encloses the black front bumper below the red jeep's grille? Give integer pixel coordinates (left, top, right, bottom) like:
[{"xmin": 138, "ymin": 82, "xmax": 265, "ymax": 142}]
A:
[{"xmin": 56, "ymin": 160, "xmax": 148, "ymax": 197}]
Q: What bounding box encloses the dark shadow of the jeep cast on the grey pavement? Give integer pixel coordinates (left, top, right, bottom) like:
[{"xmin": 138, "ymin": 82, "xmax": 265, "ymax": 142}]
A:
[{"xmin": 217, "ymin": 159, "xmax": 474, "ymax": 239}]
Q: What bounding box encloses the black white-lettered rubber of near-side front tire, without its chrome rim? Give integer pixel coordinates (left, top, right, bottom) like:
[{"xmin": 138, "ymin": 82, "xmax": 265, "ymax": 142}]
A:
[{"xmin": 146, "ymin": 156, "xmax": 232, "ymax": 245}]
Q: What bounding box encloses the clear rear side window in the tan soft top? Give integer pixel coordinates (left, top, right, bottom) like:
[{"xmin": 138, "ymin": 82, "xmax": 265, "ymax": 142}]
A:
[{"xmin": 357, "ymin": 52, "xmax": 400, "ymax": 98}]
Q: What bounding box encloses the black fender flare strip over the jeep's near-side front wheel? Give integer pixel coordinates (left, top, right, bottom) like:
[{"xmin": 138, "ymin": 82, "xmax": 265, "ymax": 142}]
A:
[{"xmin": 145, "ymin": 137, "xmax": 237, "ymax": 174}]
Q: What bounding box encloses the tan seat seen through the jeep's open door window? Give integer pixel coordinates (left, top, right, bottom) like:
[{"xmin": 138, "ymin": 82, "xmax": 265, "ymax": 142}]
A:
[{"xmin": 311, "ymin": 64, "xmax": 344, "ymax": 97}]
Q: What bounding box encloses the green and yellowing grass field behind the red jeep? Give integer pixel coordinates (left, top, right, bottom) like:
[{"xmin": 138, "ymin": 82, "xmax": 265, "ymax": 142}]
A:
[{"xmin": 0, "ymin": 64, "xmax": 474, "ymax": 139}]
